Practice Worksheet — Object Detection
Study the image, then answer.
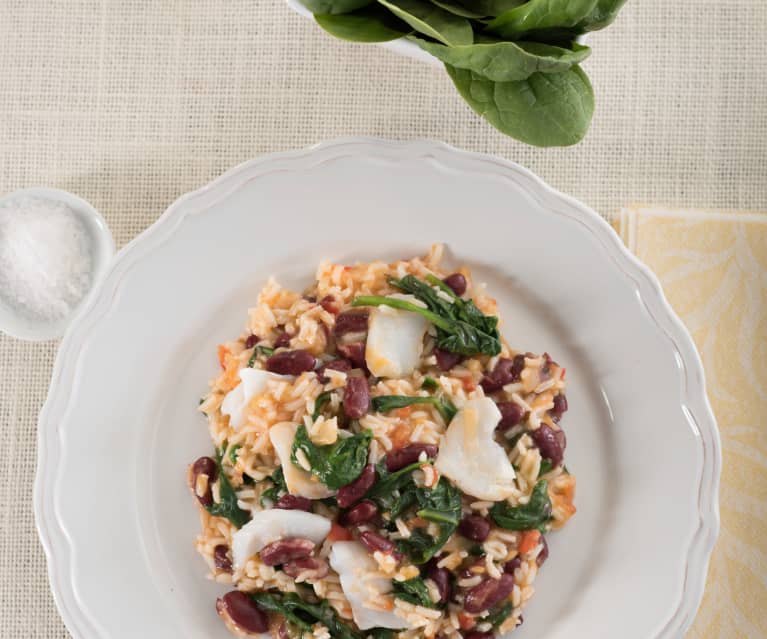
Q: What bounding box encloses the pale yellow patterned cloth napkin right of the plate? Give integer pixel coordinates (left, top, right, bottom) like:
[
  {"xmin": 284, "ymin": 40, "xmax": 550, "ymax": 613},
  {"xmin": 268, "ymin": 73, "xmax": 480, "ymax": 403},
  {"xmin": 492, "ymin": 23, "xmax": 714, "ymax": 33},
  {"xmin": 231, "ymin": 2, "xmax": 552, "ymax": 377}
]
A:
[{"xmin": 615, "ymin": 207, "xmax": 767, "ymax": 639}]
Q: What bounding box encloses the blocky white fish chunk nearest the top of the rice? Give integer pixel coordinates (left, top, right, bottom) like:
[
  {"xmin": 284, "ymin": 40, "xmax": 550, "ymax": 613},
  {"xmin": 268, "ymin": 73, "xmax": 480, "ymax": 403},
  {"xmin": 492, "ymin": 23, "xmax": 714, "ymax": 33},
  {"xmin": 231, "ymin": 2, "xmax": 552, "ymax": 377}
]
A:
[{"xmin": 365, "ymin": 294, "xmax": 429, "ymax": 377}]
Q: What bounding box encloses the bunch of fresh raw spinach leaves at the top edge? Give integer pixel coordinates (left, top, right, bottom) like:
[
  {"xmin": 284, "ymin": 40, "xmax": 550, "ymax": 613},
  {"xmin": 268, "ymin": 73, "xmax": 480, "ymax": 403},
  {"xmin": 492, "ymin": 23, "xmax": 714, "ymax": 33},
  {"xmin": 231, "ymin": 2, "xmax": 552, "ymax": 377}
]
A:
[{"xmin": 301, "ymin": 0, "xmax": 626, "ymax": 146}]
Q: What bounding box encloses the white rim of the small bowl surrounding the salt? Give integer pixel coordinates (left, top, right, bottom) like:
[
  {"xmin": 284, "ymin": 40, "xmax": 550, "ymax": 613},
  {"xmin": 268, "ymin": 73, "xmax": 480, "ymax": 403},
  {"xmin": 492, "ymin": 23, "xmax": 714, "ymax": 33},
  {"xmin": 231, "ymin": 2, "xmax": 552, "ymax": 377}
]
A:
[{"xmin": 0, "ymin": 187, "xmax": 115, "ymax": 341}]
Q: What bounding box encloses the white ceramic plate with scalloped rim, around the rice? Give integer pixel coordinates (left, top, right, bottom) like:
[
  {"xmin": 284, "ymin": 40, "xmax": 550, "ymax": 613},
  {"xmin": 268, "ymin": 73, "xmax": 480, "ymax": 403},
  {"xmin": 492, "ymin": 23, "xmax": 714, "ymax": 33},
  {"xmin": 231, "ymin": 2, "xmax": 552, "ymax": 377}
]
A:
[{"xmin": 35, "ymin": 139, "xmax": 720, "ymax": 639}]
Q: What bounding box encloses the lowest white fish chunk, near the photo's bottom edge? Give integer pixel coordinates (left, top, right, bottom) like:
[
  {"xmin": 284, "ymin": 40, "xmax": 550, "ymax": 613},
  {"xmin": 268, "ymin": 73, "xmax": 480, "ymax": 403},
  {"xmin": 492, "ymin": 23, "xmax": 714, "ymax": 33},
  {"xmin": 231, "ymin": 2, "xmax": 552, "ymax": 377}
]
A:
[{"xmin": 330, "ymin": 541, "xmax": 409, "ymax": 630}]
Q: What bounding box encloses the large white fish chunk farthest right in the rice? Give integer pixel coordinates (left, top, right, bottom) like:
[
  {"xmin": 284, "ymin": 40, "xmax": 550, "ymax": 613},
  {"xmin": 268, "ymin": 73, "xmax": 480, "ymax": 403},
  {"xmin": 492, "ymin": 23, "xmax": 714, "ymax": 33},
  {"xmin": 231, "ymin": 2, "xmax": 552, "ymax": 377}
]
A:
[{"xmin": 434, "ymin": 397, "xmax": 516, "ymax": 501}]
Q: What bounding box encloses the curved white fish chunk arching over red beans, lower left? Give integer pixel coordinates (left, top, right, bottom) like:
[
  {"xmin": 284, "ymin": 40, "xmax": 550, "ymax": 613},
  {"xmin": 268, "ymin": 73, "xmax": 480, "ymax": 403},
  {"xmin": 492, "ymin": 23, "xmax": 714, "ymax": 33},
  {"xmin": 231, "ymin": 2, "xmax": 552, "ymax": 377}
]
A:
[{"xmin": 232, "ymin": 508, "xmax": 330, "ymax": 570}]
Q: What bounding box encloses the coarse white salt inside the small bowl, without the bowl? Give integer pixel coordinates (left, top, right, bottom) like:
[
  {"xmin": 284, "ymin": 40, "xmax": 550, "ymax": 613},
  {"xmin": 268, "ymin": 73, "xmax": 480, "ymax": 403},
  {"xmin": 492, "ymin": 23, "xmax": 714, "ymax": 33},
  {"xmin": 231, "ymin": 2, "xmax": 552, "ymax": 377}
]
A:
[{"xmin": 0, "ymin": 196, "xmax": 93, "ymax": 321}]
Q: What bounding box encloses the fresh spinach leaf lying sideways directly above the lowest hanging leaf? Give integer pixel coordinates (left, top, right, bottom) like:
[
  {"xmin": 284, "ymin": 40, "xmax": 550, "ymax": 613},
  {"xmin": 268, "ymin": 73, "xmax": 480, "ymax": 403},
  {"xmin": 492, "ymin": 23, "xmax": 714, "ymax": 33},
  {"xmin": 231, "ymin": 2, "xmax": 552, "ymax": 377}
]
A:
[{"xmin": 410, "ymin": 36, "xmax": 591, "ymax": 82}]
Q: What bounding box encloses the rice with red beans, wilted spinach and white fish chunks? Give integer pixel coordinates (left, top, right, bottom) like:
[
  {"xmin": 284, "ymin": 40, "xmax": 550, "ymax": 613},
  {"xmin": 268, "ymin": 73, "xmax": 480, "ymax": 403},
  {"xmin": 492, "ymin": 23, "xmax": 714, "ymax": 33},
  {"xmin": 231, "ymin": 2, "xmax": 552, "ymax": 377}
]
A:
[{"xmin": 187, "ymin": 245, "xmax": 575, "ymax": 639}]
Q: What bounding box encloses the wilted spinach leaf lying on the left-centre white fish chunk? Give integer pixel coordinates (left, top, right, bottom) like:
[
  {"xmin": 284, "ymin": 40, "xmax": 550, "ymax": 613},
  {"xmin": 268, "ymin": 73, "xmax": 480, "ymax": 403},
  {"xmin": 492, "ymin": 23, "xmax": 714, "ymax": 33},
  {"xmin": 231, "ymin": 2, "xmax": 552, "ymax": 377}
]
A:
[{"xmin": 290, "ymin": 424, "xmax": 373, "ymax": 490}]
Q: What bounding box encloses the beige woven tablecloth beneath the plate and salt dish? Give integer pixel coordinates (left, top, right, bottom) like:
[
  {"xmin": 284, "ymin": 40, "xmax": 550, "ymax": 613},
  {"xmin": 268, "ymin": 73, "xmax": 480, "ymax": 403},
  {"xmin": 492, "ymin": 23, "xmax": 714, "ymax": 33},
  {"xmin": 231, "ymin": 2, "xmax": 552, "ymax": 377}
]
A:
[{"xmin": 0, "ymin": 0, "xmax": 767, "ymax": 639}]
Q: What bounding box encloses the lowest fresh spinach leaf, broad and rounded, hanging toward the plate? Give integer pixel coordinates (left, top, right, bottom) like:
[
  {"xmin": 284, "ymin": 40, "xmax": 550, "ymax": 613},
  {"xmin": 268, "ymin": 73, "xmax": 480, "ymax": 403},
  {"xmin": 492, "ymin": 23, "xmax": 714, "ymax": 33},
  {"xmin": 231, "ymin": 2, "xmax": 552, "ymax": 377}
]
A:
[{"xmin": 445, "ymin": 64, "xmax": 594, "ymax": 146}]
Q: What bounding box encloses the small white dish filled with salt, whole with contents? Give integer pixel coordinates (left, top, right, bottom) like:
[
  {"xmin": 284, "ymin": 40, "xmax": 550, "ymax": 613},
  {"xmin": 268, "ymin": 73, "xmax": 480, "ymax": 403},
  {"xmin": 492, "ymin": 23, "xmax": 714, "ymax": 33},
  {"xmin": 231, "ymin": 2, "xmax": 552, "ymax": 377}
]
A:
[{"xmin": 0, "ymin": 188, "xmax": 115, "ymax": 341}]
